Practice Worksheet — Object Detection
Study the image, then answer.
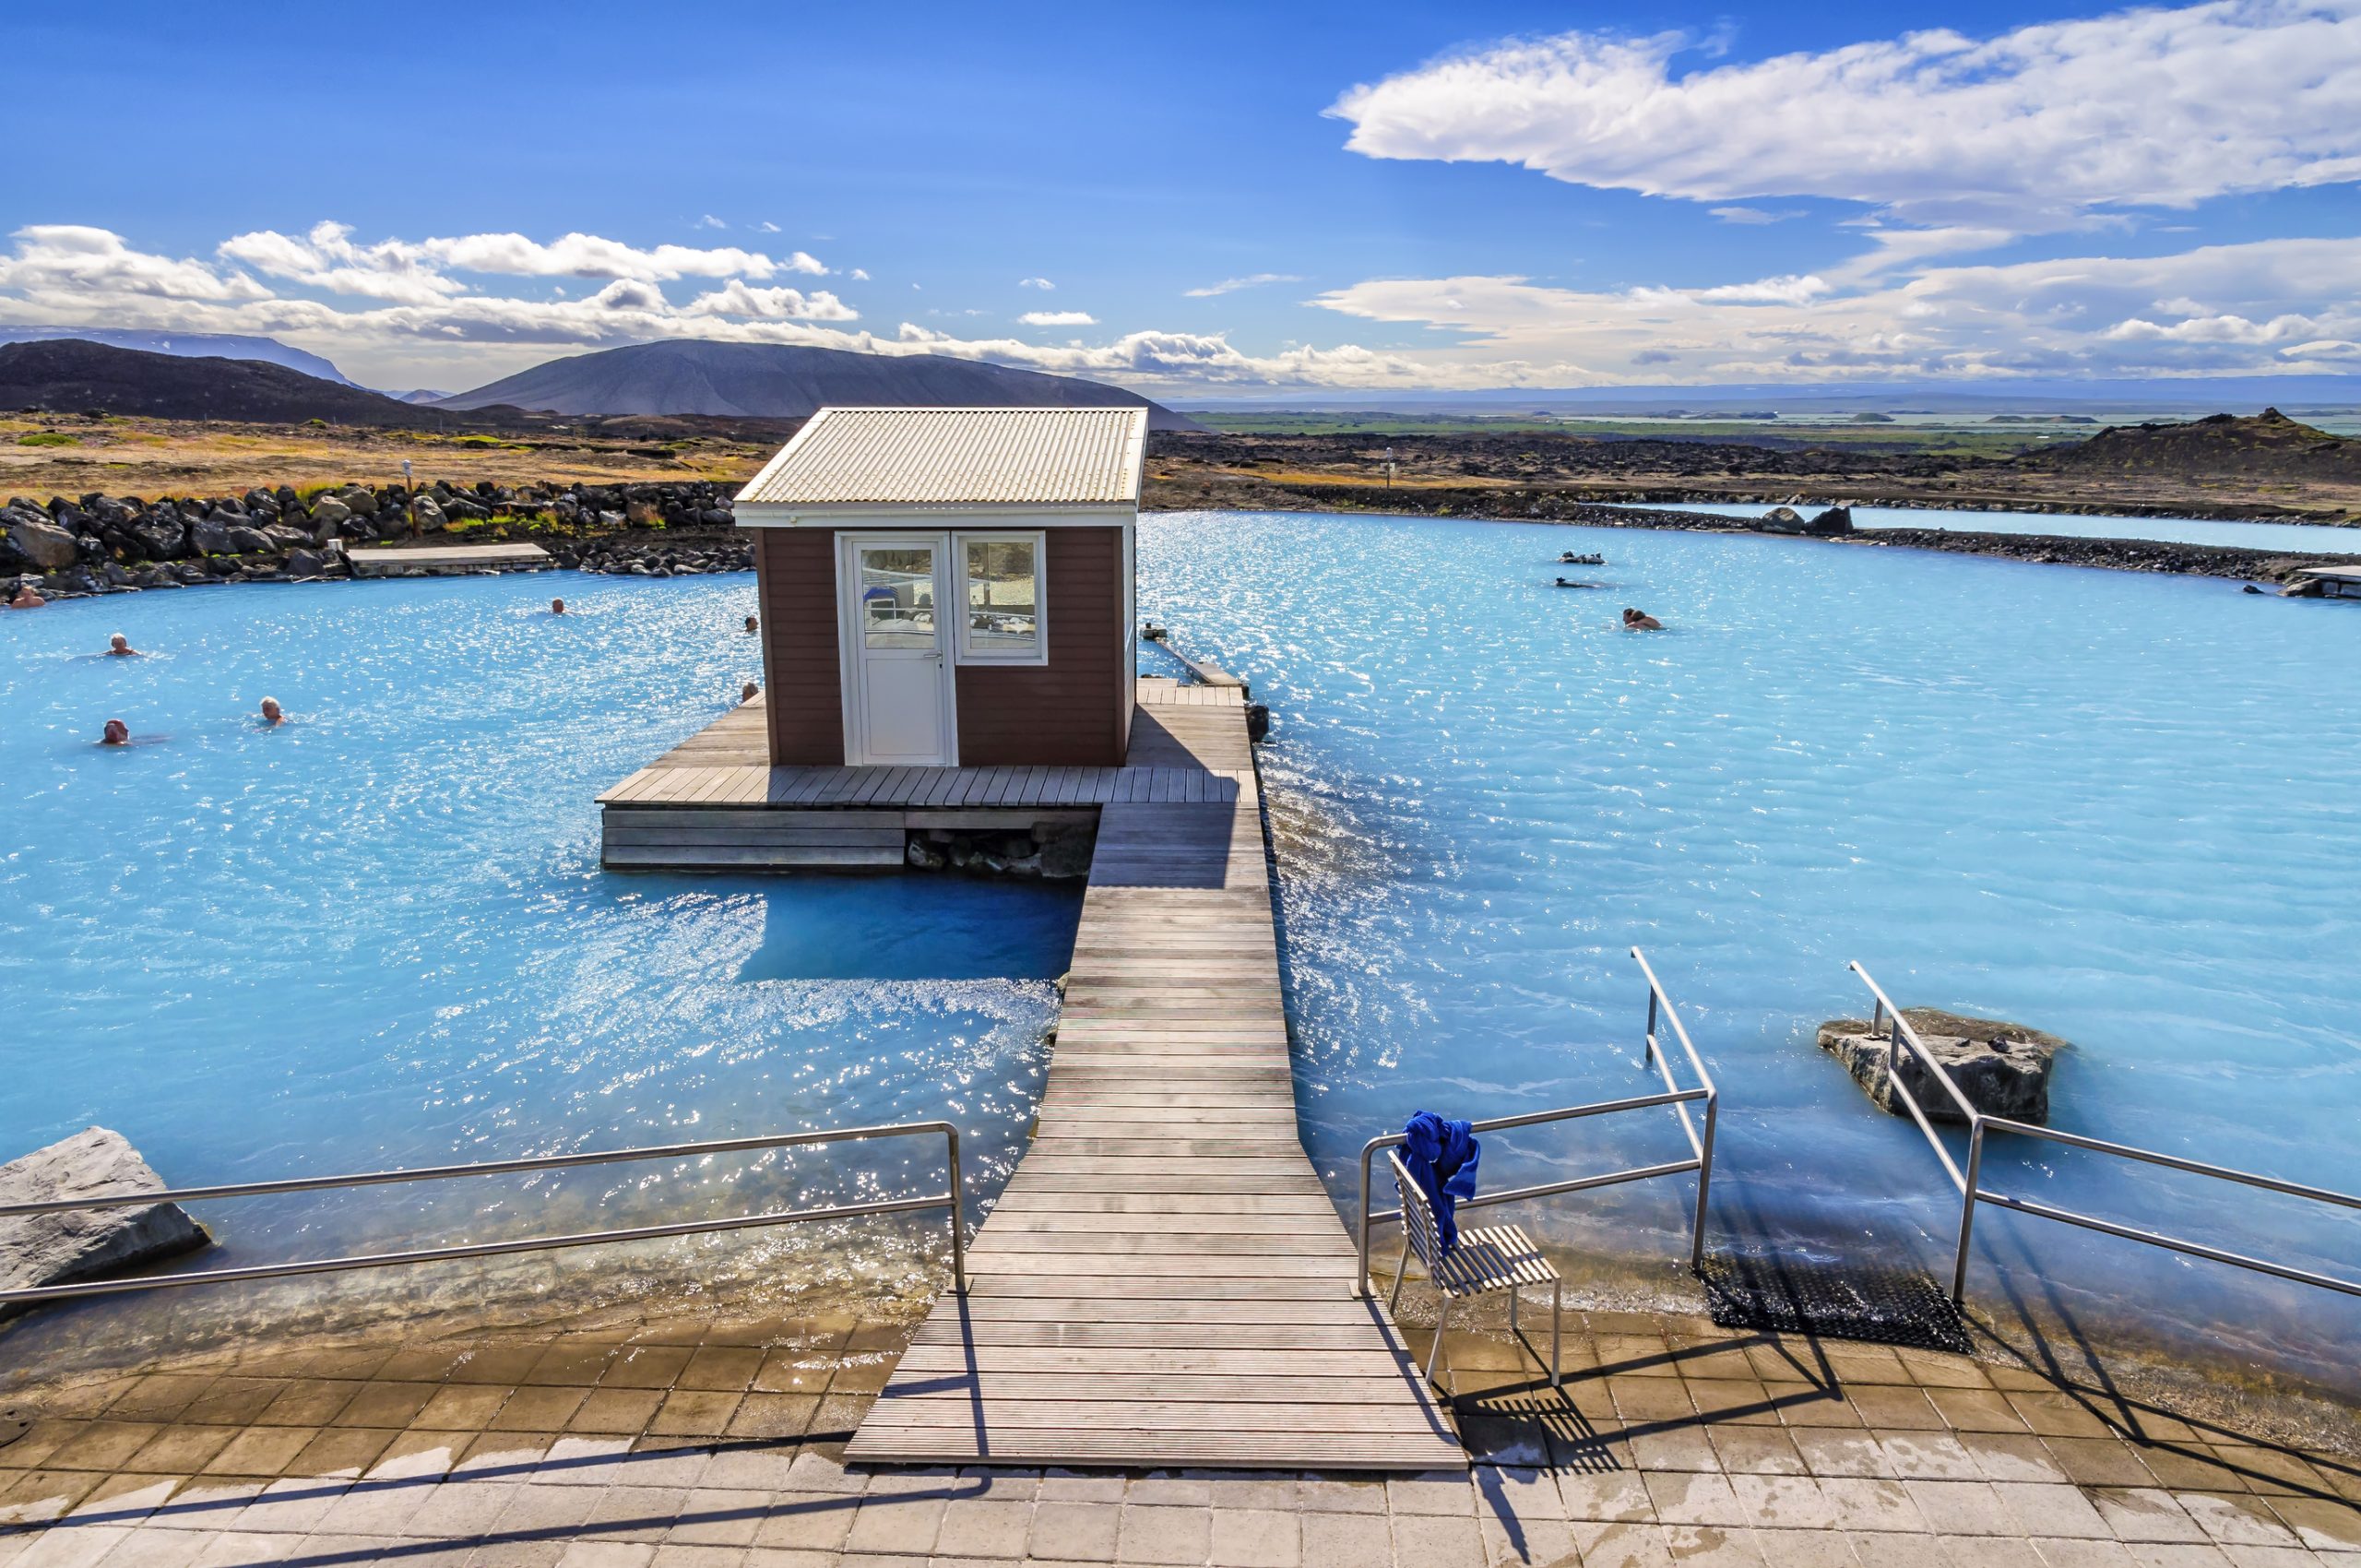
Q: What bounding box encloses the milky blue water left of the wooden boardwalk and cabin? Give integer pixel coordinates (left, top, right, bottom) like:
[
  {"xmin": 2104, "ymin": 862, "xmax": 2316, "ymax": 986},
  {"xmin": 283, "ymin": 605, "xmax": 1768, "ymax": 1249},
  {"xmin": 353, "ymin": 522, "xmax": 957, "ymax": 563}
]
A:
[{"xmin": 0, "ymin": 576, "xmax": 1079, "ymax": 1369}]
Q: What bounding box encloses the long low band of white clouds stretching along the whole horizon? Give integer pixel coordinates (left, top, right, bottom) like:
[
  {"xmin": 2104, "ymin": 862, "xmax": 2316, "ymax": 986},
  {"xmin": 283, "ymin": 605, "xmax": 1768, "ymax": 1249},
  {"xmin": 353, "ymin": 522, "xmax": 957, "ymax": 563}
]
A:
[{"xmin": 18, "ymin": 224, "xmax": 2361, "ymax": 395}]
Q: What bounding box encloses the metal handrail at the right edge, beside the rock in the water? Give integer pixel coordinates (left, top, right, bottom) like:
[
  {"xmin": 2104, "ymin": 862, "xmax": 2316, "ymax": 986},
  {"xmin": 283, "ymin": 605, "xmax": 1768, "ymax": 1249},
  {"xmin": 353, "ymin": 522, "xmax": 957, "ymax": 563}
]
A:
[{"xmin": 1846, "ymin": 964, "xmax": 2361, "ymax": 1306}]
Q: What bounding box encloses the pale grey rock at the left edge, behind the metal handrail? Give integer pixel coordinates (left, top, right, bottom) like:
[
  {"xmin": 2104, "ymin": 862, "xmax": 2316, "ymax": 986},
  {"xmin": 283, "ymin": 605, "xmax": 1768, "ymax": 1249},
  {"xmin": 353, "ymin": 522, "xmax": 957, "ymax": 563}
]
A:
[{"xmin": 0, "ymin": 1126, "xmax": 212, "ymax": 1313}]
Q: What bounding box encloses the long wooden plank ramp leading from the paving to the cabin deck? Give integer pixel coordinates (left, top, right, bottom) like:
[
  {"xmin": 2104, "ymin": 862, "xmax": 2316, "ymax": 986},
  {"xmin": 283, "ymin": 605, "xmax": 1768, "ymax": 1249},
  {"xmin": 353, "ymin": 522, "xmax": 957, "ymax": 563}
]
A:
[{"xmin": 845, "ymin": 683, "xmax": 1466, "ymax": 1471}]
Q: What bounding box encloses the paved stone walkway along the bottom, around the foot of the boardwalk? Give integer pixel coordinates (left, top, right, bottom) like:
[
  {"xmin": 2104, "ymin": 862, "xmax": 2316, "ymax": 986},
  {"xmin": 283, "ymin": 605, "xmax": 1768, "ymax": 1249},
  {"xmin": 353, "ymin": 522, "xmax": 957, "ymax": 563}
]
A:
[{"xmin": 0, "ymin": 1313, "xmax": 2361, "ymax": 1568}]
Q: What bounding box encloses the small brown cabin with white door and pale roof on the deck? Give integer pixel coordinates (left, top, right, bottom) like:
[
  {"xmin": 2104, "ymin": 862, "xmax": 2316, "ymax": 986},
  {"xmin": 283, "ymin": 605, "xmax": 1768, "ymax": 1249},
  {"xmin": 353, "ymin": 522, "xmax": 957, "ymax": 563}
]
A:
[{"xmin": 737, "ymin": 409, "xmax": 1147, "ymax": 767}]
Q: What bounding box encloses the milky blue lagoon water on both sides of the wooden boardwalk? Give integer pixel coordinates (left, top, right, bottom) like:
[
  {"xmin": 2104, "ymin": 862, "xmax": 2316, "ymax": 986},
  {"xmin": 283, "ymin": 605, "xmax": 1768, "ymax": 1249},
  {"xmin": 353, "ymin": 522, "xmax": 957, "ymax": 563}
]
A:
[{"xmin": 0, "ymin": 513, "xmax": 2361, "ymax": 1382}]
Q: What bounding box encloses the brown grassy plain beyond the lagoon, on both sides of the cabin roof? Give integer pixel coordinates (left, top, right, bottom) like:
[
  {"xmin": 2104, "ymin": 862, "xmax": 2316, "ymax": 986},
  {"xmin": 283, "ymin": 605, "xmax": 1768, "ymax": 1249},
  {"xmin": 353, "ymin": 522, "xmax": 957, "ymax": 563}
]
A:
[{"xmin": 18, "ymin": 413, "xmax": 2361, "ymax": 522}]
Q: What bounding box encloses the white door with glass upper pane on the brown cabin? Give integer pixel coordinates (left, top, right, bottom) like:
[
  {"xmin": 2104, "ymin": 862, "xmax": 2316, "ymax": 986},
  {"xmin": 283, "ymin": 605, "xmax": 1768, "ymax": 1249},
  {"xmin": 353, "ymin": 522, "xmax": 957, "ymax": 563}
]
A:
[{"xmin": 838, "ymin": 534, "xmax": 956, "ymax": 767}]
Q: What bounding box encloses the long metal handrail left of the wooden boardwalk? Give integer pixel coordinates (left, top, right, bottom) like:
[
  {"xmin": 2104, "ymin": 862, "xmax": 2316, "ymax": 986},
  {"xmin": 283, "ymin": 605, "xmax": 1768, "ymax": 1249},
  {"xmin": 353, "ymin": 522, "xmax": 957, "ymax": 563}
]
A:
[{"xmin": 0, "ymin": 1122, "xmax": 968, "ymax": 1301}]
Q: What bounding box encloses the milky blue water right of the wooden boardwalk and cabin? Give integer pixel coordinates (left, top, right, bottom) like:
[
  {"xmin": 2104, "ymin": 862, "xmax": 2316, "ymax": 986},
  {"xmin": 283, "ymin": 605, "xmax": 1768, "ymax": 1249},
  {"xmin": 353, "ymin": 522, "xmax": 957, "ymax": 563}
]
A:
[{"xmin": 1140, "ymin": 515, "xmax": 2361, "ymax": 1379}]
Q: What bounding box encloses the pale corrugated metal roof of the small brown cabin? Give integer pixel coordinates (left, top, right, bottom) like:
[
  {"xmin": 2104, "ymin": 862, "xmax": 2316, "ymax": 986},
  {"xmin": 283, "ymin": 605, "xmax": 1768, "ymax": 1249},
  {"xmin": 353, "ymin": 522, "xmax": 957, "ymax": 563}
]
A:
[{"xmin": 739, "ymin": 409, "xmax": 1147, "ymax": 507}]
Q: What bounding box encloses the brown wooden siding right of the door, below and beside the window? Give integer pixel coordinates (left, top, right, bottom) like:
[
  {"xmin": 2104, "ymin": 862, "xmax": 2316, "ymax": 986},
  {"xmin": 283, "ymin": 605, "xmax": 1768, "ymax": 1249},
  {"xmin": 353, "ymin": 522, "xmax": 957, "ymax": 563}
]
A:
[{"xmin": 949, "ymin": 527, "xmax": 1133, "ymax": 767}]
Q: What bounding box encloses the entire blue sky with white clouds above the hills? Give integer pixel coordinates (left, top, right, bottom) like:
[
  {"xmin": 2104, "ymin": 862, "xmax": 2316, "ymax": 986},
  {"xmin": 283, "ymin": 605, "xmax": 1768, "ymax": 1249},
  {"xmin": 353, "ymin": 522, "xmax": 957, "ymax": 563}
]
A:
[{"xmin": 0, "ymin": 0, "xmax": 2361, "ymax": 404}]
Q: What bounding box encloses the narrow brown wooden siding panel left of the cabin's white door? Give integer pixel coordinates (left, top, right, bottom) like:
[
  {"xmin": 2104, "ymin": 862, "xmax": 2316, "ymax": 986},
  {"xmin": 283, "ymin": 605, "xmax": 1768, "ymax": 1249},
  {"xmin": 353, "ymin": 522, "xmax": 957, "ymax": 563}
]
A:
[{"xmin": 753, "ymin": 529, "xmax": 845, "ymax": 767}]
